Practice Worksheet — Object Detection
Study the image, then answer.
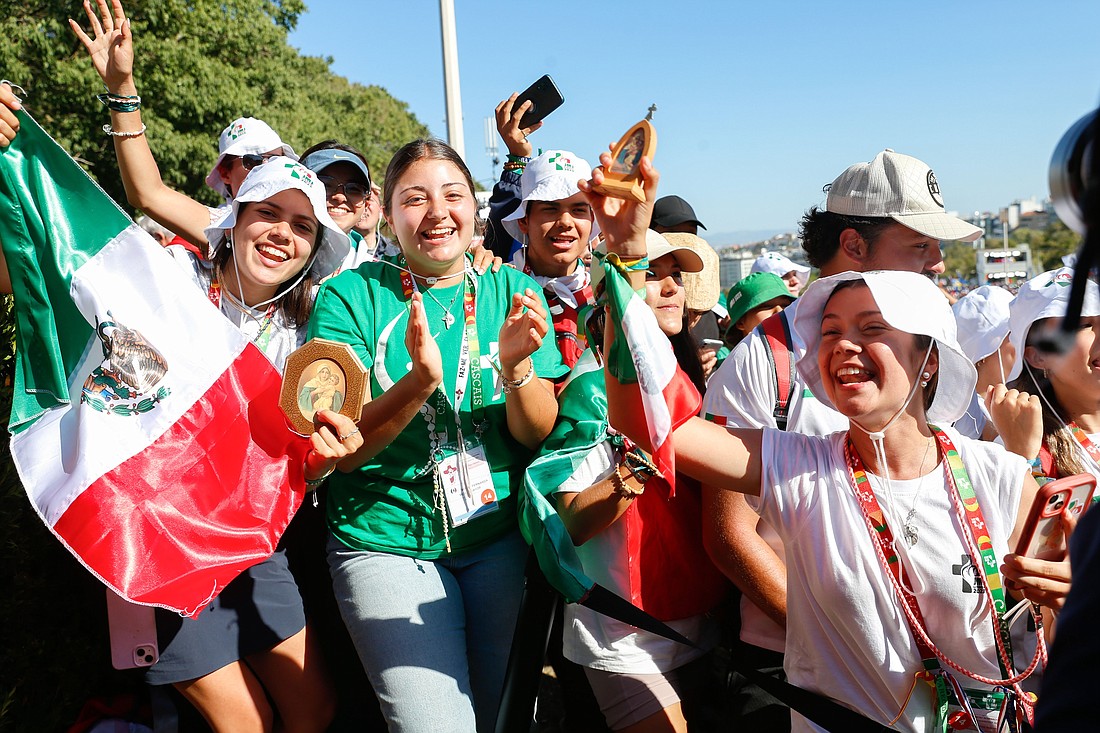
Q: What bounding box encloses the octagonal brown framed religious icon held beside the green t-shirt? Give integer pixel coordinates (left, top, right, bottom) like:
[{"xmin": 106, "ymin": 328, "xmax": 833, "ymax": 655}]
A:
[{"xmin": 278, "ymin": 339, "xmax": 366, "ymax": 435}]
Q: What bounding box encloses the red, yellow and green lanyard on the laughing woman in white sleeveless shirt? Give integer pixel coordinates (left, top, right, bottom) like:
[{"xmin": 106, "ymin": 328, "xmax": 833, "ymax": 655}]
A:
[{"xmin": 845, "ymin": 425, "xmax": 1042, "ymax": 731}]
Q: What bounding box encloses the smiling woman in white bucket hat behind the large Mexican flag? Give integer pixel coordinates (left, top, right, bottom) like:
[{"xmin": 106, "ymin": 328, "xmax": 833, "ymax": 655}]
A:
[{"xmin": 138, "ymin": 157, "xmax": 362, "ymax": 731}]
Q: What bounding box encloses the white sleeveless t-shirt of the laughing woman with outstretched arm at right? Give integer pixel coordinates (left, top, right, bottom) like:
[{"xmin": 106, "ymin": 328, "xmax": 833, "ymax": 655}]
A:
[{"xmin": 748, "ymin": 428, "xmax": 1029, "ymax": 732}]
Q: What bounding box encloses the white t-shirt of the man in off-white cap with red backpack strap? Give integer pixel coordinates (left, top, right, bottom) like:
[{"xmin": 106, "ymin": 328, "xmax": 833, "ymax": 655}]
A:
[{"xmin": 703, "ymin": 300, "xmax": 848, "ymax": 652}]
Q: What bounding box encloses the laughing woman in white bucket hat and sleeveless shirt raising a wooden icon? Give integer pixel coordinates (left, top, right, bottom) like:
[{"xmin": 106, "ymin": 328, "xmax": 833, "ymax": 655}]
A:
[{"xmin": 584, "ymin": 154, "xmax": 1068, "ymax": 732}]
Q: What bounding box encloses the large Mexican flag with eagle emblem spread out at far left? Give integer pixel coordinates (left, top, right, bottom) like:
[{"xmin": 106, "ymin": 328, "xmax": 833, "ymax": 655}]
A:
[{"xmin": 0, "ymin": 112, "xmax": 308, "ymax": 616}]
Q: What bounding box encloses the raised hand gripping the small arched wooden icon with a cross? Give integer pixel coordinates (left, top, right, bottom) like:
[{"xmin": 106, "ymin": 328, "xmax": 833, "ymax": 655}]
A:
[{"xmin": 578, "ymin": 153, "xmax": 660, "ymax": 260}]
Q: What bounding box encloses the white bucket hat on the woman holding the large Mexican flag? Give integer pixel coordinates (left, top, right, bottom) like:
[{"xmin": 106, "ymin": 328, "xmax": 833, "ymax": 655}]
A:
[{"xmin": 206, "ymin": 156, "xmax": 351, "ymax": 277}]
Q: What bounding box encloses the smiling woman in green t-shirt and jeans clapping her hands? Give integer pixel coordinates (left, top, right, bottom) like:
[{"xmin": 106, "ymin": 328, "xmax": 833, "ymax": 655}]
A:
[{"xmin": 310, "ymin": 140, "xmax": 565, "ymax": 732}]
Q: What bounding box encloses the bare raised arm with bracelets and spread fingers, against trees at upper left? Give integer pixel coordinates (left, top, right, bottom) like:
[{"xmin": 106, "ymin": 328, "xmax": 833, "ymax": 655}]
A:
[{"xmin": 69, "ymin": 0, "xmax": 210, "ymax": 245}]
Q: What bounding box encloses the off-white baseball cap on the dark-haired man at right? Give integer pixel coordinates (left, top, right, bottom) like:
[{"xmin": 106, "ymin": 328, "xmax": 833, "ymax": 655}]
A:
[{"xmin": 825, "ymin": 147, "xmax": 982, "ymax": 242}]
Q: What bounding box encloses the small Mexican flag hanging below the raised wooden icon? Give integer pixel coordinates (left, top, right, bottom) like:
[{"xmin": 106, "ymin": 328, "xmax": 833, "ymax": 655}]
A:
[{"xmin": 604, "ymin": 255, "xmax": 702, "ymax": 494}]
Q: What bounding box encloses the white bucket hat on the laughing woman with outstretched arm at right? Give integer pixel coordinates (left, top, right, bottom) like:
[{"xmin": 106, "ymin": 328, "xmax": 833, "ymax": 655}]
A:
[{"xmin": 794, "ymin": 271, "xmax": 978, "ymax": 424}]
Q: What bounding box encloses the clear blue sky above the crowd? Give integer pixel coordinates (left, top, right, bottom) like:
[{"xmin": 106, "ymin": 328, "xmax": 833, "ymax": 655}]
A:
[{"xmin": 290, "ymin": 0, "xmax": 1100, "ymax": 245}]
